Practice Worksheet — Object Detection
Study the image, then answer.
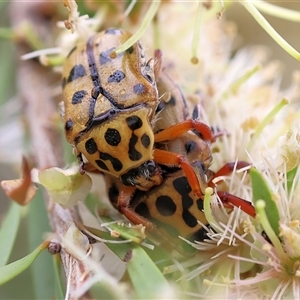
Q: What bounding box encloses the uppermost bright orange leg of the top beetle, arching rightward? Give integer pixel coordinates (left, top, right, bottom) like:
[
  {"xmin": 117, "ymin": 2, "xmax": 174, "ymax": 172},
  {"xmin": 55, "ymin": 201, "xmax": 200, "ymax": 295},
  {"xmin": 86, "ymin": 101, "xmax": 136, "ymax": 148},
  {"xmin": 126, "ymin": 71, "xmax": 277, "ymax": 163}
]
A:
[{"xmin": 154, "ymin": 119, "xmax": 215, "ymax": 142}]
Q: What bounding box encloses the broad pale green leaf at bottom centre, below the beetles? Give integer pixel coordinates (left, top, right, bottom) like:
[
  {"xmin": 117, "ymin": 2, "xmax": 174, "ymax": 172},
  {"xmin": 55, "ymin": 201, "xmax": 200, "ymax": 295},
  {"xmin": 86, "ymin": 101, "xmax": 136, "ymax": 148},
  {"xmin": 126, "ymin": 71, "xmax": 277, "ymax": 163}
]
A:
[{"xmin": 124, "ymin": 245, "xmax": 171, "ymax": 299}]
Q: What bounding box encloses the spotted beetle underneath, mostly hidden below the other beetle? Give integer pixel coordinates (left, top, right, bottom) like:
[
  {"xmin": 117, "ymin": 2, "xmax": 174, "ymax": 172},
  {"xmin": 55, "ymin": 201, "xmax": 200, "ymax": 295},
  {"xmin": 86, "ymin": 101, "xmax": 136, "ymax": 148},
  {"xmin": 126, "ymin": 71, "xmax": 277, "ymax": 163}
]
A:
[{"xmin": 104, "ymin": 54, "xmax": 255, "ymax": 250}]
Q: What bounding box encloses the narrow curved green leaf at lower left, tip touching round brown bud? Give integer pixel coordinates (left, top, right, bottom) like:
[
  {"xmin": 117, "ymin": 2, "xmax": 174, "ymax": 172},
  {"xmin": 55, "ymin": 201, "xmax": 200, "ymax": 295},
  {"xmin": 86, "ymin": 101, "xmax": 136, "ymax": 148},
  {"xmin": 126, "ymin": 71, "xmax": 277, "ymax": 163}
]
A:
[{"xmin": 0, "ymin": 243, "xmax": 48, "ymax": 285}]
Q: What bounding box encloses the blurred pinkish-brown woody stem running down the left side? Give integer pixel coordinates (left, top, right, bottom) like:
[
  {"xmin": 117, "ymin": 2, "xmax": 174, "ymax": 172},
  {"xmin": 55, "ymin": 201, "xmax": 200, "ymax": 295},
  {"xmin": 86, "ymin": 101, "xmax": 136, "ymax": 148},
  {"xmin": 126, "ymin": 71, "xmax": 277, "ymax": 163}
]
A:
[{"xmin": 11, "ymin": 1, "xmax": 86, "ymax": 297}]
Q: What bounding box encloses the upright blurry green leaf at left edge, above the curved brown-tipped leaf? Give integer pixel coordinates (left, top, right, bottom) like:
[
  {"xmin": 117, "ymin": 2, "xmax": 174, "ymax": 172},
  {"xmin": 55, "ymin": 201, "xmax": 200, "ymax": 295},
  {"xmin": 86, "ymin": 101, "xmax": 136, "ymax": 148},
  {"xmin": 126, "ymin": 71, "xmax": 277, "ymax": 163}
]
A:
[{"xmin": 0, "ymin": 202, "xmax": 22, "ymax": 267}]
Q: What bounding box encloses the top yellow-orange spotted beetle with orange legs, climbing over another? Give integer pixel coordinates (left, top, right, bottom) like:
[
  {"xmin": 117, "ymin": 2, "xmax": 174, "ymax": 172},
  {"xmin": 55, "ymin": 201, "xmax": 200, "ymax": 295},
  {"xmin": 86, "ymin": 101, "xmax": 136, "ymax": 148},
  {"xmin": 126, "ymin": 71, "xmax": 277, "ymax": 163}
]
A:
[{"xmin": 62, "ymin": 28, "xmax": 214, "ymax": 223}]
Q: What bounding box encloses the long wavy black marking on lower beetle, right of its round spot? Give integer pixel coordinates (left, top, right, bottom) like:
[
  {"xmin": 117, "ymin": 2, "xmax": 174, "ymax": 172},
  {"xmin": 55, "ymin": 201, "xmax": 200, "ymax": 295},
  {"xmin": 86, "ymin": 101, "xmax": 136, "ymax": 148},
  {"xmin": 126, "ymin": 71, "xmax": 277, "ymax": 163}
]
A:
[{"xmin": 173, "ymin": 177, "xmax": 198, "ymax": 228}]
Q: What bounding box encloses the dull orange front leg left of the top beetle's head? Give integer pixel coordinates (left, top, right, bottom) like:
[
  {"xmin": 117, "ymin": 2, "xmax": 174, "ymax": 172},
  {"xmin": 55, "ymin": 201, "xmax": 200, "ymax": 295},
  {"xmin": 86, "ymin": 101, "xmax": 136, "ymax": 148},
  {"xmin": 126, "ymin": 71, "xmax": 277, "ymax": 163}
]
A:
[{"xmin": 117, "ymin": 186, "xmax": 155, "ymax": 230}]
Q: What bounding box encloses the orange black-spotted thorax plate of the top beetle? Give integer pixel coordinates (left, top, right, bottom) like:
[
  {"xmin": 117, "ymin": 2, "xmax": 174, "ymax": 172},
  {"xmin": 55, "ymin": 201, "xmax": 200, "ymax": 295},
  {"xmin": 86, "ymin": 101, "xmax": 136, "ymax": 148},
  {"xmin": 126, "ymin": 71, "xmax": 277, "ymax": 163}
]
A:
[{"xmin": 75, "ymin": 107, "xmax": 154, "ymax": 177}]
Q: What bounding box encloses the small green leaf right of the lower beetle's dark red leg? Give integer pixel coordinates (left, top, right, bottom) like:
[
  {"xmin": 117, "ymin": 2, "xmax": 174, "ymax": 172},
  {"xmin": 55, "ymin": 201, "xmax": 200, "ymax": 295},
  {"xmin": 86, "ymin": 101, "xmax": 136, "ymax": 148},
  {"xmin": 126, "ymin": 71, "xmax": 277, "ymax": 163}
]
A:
[{"xmin": 250, "ymin": 168, "xmax": 279, "ymax": 236}]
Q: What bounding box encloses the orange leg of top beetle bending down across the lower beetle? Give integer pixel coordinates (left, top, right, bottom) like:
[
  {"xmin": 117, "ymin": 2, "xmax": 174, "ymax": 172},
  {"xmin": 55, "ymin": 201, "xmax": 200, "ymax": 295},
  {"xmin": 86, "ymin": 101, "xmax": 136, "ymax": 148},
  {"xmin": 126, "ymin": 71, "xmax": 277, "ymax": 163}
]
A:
[{"xmin": 153, "ymin": 149, "xmax": 203, "ymax": 198}]
